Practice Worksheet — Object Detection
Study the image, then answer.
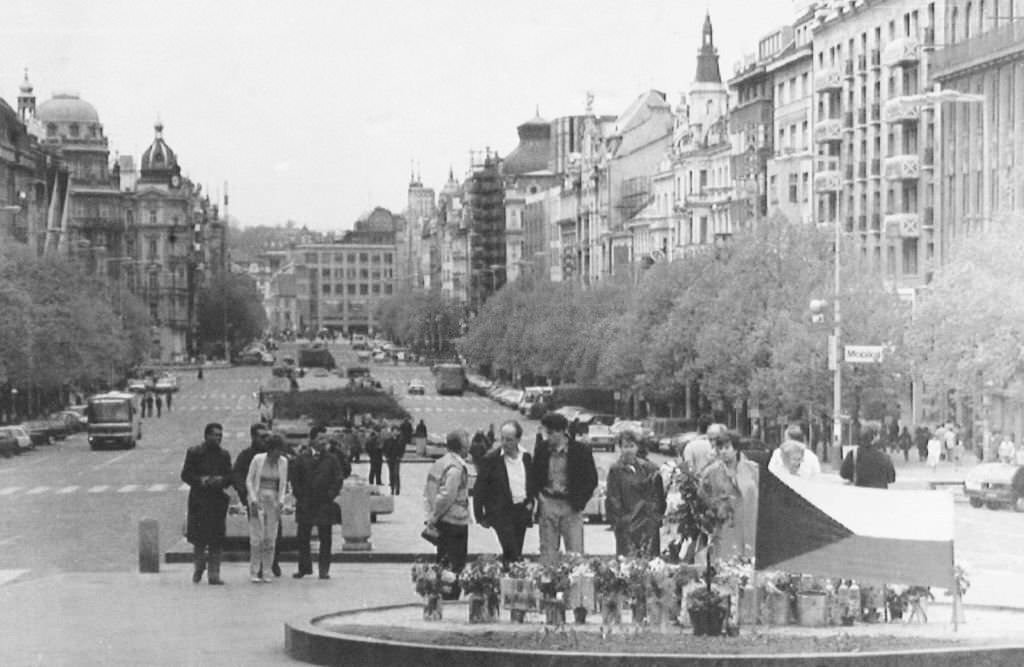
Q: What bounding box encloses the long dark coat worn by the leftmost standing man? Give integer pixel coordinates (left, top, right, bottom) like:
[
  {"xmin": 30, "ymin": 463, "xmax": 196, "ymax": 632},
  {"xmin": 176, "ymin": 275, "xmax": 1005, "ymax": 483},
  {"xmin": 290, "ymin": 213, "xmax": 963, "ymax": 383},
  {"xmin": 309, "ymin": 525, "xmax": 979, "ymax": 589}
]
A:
[{"xmin": 181, "ymin": 444, "xmax": 234, "ymax": 545}]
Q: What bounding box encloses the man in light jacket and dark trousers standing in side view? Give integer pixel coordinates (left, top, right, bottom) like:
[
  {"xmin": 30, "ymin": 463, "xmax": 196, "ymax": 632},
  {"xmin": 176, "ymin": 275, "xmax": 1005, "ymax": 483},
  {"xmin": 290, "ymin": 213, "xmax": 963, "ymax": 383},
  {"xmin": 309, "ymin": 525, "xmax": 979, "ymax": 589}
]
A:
[{"xmin": 423, "ymin": 431, "xmax": 469, "ymax": 599}]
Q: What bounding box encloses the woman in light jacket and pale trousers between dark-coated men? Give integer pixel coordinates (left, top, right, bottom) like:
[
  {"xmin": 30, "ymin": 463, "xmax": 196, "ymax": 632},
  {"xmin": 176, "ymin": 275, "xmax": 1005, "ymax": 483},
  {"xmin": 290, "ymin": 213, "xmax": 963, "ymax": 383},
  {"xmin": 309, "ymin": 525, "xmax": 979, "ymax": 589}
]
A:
[{"xmin": 246, "ymin": 433, "xmax": 288, "ymax": 584}]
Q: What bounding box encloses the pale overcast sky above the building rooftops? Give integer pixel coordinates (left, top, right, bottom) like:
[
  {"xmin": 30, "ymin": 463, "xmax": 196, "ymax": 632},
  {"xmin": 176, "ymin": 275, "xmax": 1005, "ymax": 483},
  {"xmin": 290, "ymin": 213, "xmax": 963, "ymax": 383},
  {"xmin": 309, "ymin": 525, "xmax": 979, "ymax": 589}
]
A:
[{"xmin": 0, "ymin": 0, "xmax": 794, "ymax": 230}]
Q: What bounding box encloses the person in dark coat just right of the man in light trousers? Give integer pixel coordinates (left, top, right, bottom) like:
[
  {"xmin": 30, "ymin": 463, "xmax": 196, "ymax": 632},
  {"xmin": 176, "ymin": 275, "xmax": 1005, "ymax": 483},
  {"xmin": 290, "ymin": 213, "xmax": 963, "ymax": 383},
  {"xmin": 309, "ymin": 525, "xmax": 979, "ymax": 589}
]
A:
[{"xmin": 605, "ymin": 431, "xmax": 666, "ymax": 558}]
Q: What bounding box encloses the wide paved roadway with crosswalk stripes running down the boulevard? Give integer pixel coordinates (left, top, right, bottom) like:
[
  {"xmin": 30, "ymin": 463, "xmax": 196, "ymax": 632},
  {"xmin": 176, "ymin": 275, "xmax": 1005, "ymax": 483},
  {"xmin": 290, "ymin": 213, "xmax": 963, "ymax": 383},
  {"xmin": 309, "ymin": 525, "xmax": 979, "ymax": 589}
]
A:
[{"xmin": 0, "ymin": 345, "xmax": 1024, "ymax": 603}]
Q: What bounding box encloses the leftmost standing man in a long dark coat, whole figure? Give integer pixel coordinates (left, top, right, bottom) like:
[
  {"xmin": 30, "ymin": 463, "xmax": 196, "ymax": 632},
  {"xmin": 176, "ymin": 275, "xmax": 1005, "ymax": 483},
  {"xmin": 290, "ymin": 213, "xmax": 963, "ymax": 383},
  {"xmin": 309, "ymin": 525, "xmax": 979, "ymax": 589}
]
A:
[{"xmin": 181, "ymin": 423, "xmax": 232, "ymax": 586}]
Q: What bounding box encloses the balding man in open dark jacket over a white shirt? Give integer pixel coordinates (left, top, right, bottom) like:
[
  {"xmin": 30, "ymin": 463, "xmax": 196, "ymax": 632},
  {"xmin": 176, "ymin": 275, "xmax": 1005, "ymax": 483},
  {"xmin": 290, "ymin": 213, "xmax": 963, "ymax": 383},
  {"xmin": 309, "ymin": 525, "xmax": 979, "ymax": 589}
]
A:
[{"xmin": 473, "ymin": 419, "xmax": 537, "ymax": 565}]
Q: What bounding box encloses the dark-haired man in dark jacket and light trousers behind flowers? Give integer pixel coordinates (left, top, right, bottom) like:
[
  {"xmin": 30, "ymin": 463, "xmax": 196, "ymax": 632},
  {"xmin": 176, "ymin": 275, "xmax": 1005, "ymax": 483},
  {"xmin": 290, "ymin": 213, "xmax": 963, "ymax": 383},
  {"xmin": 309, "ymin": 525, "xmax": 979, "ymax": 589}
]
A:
[{"xmin": 534, "ymin": 412, "xmax": 597, "ymax": 562}]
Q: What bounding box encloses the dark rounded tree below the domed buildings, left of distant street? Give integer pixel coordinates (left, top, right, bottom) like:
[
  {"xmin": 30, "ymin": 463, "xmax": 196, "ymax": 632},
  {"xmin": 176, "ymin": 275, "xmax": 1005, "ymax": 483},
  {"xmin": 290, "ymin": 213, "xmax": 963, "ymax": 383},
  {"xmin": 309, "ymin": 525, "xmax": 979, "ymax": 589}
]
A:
[{"xmin": 197, "ymin": 272, "xmax": 267, "ymax": 353}]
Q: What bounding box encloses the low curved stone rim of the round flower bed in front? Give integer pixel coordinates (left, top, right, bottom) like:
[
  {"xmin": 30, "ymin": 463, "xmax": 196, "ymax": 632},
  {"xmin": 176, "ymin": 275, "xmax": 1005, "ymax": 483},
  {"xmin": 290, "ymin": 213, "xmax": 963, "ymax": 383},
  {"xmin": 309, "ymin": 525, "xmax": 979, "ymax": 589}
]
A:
[{"xmin": 285, "ymin": 605, "xmax": 1024, "ymax": 667}]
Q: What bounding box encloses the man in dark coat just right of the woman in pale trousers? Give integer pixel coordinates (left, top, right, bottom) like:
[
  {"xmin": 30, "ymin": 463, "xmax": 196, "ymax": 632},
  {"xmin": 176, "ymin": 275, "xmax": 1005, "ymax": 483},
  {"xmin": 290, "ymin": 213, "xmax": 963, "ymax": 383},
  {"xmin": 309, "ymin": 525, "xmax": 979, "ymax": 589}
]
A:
[{"xmin": 291, "ymin": 435, "xmax": 342, "ymax": 579}]
